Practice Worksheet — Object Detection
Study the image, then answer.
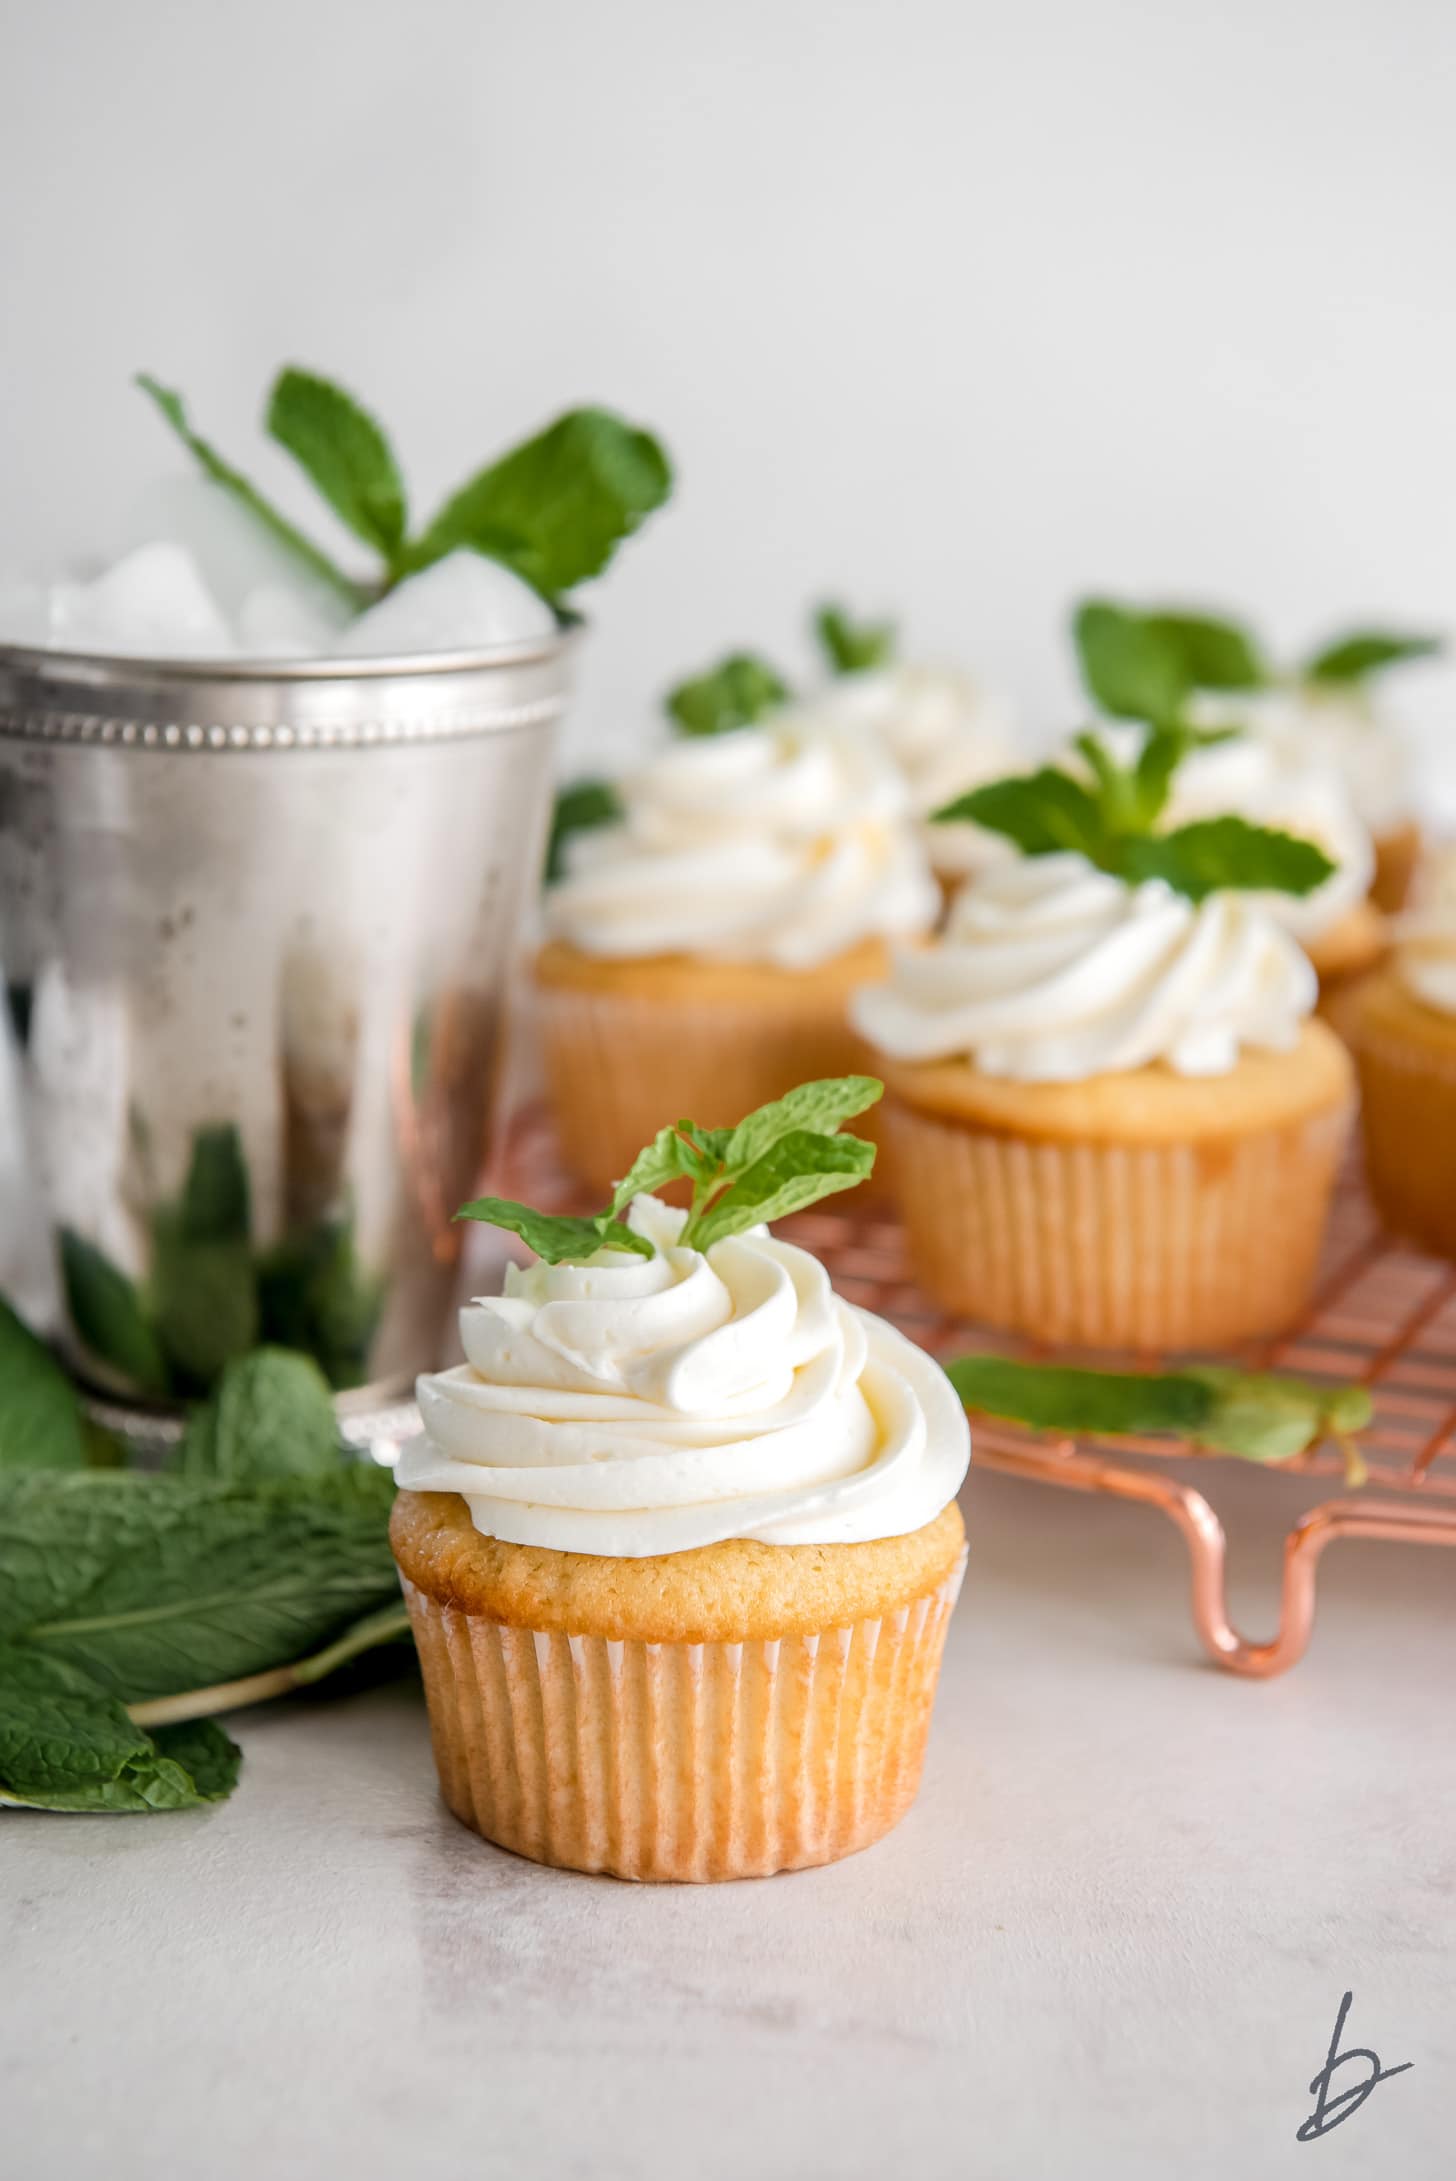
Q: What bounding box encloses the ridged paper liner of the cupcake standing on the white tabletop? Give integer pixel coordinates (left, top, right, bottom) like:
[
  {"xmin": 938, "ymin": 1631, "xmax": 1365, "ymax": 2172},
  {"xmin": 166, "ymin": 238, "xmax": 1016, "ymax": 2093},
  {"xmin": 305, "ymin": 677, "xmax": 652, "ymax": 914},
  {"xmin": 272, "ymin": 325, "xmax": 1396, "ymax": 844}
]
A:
[{"xmin": 403, "ymin": 1553, "xmax": 966, "ymax": 1882}]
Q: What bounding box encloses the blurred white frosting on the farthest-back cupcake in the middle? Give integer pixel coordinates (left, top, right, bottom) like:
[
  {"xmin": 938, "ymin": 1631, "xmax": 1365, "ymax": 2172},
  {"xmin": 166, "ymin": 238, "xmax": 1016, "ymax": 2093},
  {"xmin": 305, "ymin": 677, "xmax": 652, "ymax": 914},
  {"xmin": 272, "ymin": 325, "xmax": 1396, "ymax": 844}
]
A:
[{"xmin": 798, "ymin": 665, "xmax": 1018, "ymax": 879}]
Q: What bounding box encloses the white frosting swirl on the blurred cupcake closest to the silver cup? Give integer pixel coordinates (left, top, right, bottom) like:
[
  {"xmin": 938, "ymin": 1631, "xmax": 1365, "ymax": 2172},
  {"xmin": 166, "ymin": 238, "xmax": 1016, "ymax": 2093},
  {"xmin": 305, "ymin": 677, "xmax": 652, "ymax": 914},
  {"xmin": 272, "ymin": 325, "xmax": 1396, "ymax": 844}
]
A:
[{"xmin": 545, "ymin": 713, "xmax": 937, "ymax": 968}]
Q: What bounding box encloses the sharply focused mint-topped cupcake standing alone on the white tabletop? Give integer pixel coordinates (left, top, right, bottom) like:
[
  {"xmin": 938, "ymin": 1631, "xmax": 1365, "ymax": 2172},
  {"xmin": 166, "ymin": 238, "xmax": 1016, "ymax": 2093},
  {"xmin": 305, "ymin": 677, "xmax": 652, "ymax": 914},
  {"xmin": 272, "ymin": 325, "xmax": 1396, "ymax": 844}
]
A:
[{"xmin": 392, "ymin": 1084, "xmax": 970, "ymax": 1880}]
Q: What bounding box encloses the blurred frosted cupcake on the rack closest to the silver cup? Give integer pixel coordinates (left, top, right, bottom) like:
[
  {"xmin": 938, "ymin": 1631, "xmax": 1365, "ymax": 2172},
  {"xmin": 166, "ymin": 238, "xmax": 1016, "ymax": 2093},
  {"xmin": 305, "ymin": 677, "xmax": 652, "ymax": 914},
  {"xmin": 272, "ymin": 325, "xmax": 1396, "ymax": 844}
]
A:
[{"xmin": 534, "ymin": 661, "xmax": 939, "ymax": 1193}]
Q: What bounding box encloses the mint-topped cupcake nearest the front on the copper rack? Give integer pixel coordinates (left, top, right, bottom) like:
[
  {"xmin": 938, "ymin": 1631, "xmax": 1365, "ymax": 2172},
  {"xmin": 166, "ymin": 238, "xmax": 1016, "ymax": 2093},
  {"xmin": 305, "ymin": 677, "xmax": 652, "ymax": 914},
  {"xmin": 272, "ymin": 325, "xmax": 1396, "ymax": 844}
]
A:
[{"xmin": 852, "ymin": 746, "xmax": 1354, "ymax": 1348}]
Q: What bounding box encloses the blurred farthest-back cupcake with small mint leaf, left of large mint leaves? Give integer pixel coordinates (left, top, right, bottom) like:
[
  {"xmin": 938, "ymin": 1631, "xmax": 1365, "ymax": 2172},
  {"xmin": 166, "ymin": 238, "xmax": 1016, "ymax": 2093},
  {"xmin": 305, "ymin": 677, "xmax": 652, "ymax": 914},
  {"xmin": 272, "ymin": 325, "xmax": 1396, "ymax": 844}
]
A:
[{"xmin": 798, "ymin": 604, "xmax": 1018, "ymax": 892}]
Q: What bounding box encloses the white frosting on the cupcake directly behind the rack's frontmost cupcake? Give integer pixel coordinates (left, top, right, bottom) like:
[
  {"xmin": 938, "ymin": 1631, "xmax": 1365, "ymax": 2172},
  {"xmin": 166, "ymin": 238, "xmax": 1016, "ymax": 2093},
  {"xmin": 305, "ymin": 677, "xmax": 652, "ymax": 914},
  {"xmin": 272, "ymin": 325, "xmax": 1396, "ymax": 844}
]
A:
[{"xmin": 1077, "ymin": 724, "xmax": 1375, "ymax": 942}]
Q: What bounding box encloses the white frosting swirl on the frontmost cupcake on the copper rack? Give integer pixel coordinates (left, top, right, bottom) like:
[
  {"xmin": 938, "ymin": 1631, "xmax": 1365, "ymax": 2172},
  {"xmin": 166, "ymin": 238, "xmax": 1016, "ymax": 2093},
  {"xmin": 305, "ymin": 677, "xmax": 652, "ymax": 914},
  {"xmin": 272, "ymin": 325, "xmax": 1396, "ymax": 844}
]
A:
[{"xmin": 850, "ymin": 855, "xmax": 1317, "ymax": 1082}]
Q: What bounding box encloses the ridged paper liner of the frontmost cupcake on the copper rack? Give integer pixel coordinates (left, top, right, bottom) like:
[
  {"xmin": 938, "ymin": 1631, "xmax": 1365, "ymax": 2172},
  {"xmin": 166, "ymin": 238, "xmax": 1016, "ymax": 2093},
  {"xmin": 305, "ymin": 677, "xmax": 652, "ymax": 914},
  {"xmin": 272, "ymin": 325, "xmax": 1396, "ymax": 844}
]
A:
[{"xmin": 885, "ymin": 1099, "xmax": 1349, "ymax": 1348}]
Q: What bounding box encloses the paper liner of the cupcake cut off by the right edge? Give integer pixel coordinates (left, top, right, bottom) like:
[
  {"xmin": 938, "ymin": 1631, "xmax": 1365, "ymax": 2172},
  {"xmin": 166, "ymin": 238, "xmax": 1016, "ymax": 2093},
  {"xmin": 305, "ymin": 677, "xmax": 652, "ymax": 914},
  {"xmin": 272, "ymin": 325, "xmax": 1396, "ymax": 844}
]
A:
[{"xmin": 1354, "ymin": 1016, "xmax": 1456, "ymax": 1256}]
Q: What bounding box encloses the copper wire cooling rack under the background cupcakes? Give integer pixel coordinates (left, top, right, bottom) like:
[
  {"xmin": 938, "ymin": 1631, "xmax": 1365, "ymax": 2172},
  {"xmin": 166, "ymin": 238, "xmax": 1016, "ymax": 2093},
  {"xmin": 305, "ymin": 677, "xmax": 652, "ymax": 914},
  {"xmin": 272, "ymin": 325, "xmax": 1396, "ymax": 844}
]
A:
[{"xmin": 503, "ymin": 1108, "xmax": 1456, "ymax": 1679}]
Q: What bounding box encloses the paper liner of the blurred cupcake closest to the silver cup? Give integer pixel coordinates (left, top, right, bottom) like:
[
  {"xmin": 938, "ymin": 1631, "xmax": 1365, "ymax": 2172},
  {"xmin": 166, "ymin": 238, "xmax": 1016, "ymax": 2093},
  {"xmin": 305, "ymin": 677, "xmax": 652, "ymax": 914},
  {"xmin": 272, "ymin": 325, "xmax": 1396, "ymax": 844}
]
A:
[{"xmin": 536, "ymin": 988, "xmax": 874, "ymax": 1195}]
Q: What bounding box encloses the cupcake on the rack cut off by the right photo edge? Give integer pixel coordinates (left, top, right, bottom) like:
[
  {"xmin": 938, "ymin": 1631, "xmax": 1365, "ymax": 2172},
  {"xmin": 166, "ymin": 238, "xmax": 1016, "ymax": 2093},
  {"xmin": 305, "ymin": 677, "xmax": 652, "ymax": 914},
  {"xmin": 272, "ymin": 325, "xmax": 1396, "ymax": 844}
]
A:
[{"xmin": 1351, "ymin": 851, "xmax": 1456, "ymax": 1256}]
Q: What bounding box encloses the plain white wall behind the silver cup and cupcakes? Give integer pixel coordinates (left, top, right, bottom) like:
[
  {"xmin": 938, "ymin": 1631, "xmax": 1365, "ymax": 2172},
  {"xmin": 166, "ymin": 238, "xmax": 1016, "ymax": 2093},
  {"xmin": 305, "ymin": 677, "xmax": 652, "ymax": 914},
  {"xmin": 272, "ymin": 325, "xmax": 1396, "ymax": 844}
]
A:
[{"xmin": 0, "ymin": 0, "xmax": 1456, "ymax": 785}]
